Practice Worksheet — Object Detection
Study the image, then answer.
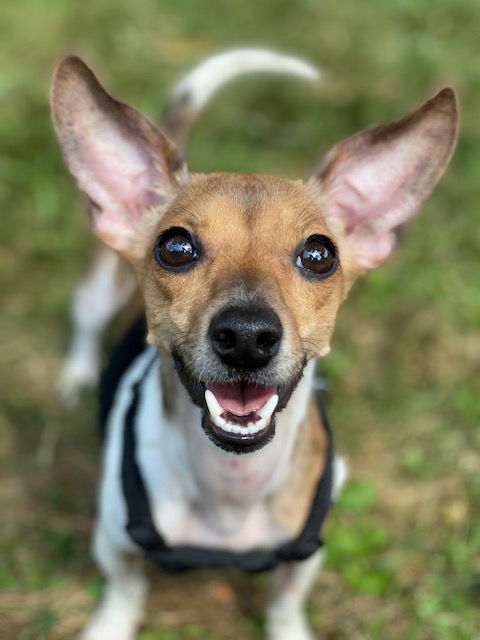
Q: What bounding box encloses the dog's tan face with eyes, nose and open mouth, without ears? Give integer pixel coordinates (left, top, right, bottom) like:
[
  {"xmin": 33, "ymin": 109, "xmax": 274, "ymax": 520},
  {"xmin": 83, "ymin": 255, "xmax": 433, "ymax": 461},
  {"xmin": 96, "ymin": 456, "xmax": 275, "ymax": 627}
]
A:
[{"xmin": 137, "ymin": 174, "xmax": 345, "ymax": 452}]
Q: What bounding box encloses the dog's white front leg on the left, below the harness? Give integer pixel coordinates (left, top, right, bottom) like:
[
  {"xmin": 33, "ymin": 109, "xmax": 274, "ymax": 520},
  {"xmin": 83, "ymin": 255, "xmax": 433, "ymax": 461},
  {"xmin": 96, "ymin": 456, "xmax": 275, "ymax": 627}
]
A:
[{"xmin": 80, "ymin": 527, "xmax": 148, "ymax": 640}]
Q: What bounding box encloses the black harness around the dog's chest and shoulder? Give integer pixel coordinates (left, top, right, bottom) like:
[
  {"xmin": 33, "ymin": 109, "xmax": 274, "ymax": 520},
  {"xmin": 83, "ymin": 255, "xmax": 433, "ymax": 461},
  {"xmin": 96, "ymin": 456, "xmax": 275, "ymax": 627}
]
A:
[{"xmin": 100, "ymin": 318, "xmax": 333, "ymax": 573}]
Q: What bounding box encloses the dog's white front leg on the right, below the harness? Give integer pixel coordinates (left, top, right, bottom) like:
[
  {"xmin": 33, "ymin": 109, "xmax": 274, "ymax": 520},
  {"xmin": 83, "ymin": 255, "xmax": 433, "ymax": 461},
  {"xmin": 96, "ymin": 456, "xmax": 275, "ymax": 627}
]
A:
[{"xmin": 267, "ymin": 551, "xmax": 323, "ymax": 640}]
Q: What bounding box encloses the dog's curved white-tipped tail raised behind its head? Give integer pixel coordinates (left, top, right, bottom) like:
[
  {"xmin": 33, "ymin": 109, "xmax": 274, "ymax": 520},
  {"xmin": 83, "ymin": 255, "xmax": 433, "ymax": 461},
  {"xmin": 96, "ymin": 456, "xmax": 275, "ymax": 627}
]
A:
[{"xmin": 162, "ymin": 48, "xmax": 320, "ymax": 147}]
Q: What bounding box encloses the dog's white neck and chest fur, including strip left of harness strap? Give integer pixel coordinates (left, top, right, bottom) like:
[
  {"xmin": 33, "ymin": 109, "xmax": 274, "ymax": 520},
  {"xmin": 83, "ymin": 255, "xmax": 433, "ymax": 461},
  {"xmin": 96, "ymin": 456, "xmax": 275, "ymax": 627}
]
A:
[{"xmin": 105, "ymin": 352, "xmax": 316, "ymax": 551}]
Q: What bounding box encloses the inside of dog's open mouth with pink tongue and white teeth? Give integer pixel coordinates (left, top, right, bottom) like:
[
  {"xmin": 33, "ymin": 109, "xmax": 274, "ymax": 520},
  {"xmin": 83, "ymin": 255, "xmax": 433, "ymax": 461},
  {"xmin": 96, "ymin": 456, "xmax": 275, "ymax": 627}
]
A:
[{"xmin": 205, "ymin": 381, "xmax": 279, "ymax": 448}]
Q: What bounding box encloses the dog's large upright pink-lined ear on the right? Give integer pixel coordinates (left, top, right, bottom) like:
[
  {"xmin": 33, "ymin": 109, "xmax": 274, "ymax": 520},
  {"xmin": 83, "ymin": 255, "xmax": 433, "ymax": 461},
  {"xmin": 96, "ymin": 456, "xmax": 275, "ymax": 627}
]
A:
[{"xmin": 309, "ymin": 88, "xmax": 458, "ymax": 272}]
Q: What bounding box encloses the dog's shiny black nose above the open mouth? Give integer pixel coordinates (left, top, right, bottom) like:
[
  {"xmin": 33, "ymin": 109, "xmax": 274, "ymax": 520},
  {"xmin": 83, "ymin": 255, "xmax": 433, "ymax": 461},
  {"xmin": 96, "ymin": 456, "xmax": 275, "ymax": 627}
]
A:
[{"xmin": 210, "ymin": 305, "xmax": 283, "ymax": 369}]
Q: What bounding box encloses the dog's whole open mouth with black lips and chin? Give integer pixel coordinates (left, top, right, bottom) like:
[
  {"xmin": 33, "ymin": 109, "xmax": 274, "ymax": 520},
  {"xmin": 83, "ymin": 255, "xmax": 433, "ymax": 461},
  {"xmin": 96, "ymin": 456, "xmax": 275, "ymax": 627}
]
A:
[{"xmin": 174, "ymin": 354, "xmax": 304, "ymax": 455}]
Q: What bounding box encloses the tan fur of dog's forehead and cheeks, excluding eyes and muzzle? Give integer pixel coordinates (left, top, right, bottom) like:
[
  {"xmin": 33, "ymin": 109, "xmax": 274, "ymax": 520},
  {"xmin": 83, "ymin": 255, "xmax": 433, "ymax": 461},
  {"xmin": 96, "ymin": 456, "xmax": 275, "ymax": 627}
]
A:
[{"xmin": 137, "ymin": 174, "xmax": 345, "ymax": 359}]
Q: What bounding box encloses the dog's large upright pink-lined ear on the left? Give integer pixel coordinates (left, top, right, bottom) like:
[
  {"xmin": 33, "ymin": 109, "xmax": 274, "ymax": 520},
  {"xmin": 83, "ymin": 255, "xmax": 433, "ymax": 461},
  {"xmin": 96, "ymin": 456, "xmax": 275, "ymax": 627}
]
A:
[{"xmin": 51, "ymin": 57, "xmax": 187, "ymax": 258}]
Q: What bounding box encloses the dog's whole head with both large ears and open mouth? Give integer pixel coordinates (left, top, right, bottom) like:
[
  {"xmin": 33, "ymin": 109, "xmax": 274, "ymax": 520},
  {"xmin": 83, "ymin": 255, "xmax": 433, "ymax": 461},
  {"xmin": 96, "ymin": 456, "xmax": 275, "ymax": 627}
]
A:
[{"xmin": 52, "ymin": 58, "xmax": 457, "ymax": 452}]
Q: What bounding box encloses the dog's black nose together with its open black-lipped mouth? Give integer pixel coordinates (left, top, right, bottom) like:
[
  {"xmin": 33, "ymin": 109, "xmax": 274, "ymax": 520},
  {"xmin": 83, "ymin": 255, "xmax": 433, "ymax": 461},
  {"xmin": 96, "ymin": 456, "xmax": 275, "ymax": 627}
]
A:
[{"xmin": 174, "ymin": 304, "xmax": 305, "ymax": 453}]
